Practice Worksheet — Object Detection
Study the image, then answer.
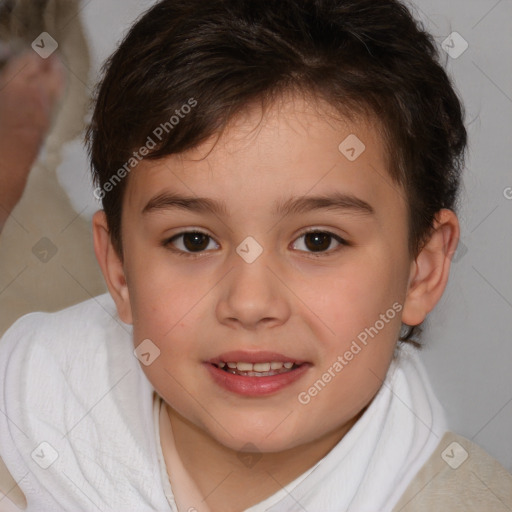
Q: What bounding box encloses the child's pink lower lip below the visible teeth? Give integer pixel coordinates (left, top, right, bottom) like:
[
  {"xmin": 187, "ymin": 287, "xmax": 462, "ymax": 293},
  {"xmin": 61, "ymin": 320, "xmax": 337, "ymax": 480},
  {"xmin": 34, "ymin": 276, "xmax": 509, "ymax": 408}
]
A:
[{"xmin": 205, "ymin": 363, "xmax": 311, "ymax": 396}]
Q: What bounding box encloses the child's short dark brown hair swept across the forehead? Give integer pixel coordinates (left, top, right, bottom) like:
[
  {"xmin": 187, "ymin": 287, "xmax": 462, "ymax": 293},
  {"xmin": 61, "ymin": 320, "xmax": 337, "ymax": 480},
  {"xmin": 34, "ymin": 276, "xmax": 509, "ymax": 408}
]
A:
[{"xmin": 86, "ymin": 0, "xmax": 466, "ymax": 344}]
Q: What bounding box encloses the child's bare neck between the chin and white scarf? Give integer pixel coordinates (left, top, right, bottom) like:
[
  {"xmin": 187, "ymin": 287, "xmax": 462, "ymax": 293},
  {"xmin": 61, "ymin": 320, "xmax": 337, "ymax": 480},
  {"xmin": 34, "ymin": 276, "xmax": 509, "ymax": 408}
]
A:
[{"xmin": 162, "ymin": 404, "xmax": 364, "ymax": 512}]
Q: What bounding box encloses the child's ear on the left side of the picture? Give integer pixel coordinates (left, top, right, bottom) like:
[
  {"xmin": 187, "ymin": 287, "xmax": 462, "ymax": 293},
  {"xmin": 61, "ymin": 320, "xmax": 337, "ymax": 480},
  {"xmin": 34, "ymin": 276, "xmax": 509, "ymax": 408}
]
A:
[{"xmin": 92, "ymin": 210, "xmax": 133, "ymax": 324}]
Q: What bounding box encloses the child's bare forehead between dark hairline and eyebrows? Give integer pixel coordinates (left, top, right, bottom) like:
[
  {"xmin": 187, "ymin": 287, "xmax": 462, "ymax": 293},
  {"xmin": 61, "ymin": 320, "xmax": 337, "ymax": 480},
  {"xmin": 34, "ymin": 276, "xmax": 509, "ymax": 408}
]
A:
[{"xmin": 124, "ymin": 96, "xmax": 404, "ymax": 221}]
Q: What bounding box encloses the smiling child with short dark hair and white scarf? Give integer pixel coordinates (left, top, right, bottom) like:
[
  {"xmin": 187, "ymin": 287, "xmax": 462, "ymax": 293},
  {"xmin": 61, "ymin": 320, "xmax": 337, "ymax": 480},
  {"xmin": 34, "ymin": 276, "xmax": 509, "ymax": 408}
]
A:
[{"xmin": 0, "ymin": 0, "xmax": 512, "ymax": 512}]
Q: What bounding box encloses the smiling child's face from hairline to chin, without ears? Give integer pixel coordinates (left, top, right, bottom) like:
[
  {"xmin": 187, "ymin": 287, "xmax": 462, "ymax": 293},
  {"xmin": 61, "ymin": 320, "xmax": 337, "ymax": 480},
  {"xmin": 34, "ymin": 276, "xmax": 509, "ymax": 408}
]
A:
[{"xmin": 115, "ymin": 94, "xmax": 411, "ymax": 452}]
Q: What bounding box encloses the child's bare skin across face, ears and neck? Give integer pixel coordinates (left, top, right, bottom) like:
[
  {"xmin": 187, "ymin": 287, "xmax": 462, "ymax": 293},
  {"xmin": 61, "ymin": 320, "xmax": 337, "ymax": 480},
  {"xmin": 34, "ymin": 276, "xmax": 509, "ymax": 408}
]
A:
[{"xmin": 93, "ymin": 96, "xmax": 459, "ymax": 512}]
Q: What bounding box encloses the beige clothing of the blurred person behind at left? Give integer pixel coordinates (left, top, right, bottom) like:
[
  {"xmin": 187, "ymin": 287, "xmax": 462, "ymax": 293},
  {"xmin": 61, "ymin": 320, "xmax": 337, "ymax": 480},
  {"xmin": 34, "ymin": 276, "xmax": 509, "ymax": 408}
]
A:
[{"xmin": 0, "ymin": 0, "xmax": 106, "ymax": 335}]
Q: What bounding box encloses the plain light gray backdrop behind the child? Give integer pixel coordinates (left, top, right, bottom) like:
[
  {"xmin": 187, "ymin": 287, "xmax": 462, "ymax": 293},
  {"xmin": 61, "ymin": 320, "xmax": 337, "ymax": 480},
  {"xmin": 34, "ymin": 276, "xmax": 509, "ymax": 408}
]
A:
[{"xmin": 59, "ymin": 0, "xmax": 512, "ymax": 472}]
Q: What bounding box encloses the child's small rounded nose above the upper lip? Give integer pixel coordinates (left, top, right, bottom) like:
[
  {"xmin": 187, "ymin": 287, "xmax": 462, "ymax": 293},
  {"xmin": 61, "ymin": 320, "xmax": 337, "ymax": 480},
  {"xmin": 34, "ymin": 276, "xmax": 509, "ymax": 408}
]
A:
[{"xmin": 216, "ymin": 251, "xmax": 290, "ymax": 330}]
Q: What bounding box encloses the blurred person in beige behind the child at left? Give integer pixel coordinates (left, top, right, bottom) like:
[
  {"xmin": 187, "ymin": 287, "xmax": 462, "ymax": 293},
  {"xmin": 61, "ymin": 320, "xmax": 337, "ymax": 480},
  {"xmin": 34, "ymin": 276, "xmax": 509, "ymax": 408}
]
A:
[{"xmin": 0, "ymin": 0, "xmax": 105, "ymax": 335}]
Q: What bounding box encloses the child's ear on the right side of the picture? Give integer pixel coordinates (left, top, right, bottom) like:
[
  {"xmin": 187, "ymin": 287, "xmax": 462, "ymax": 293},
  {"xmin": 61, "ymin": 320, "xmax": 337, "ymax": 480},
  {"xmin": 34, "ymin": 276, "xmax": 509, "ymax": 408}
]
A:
[{"xmin": 402, "ymin": 209, "xmax": 460, "ymax": 325}]
